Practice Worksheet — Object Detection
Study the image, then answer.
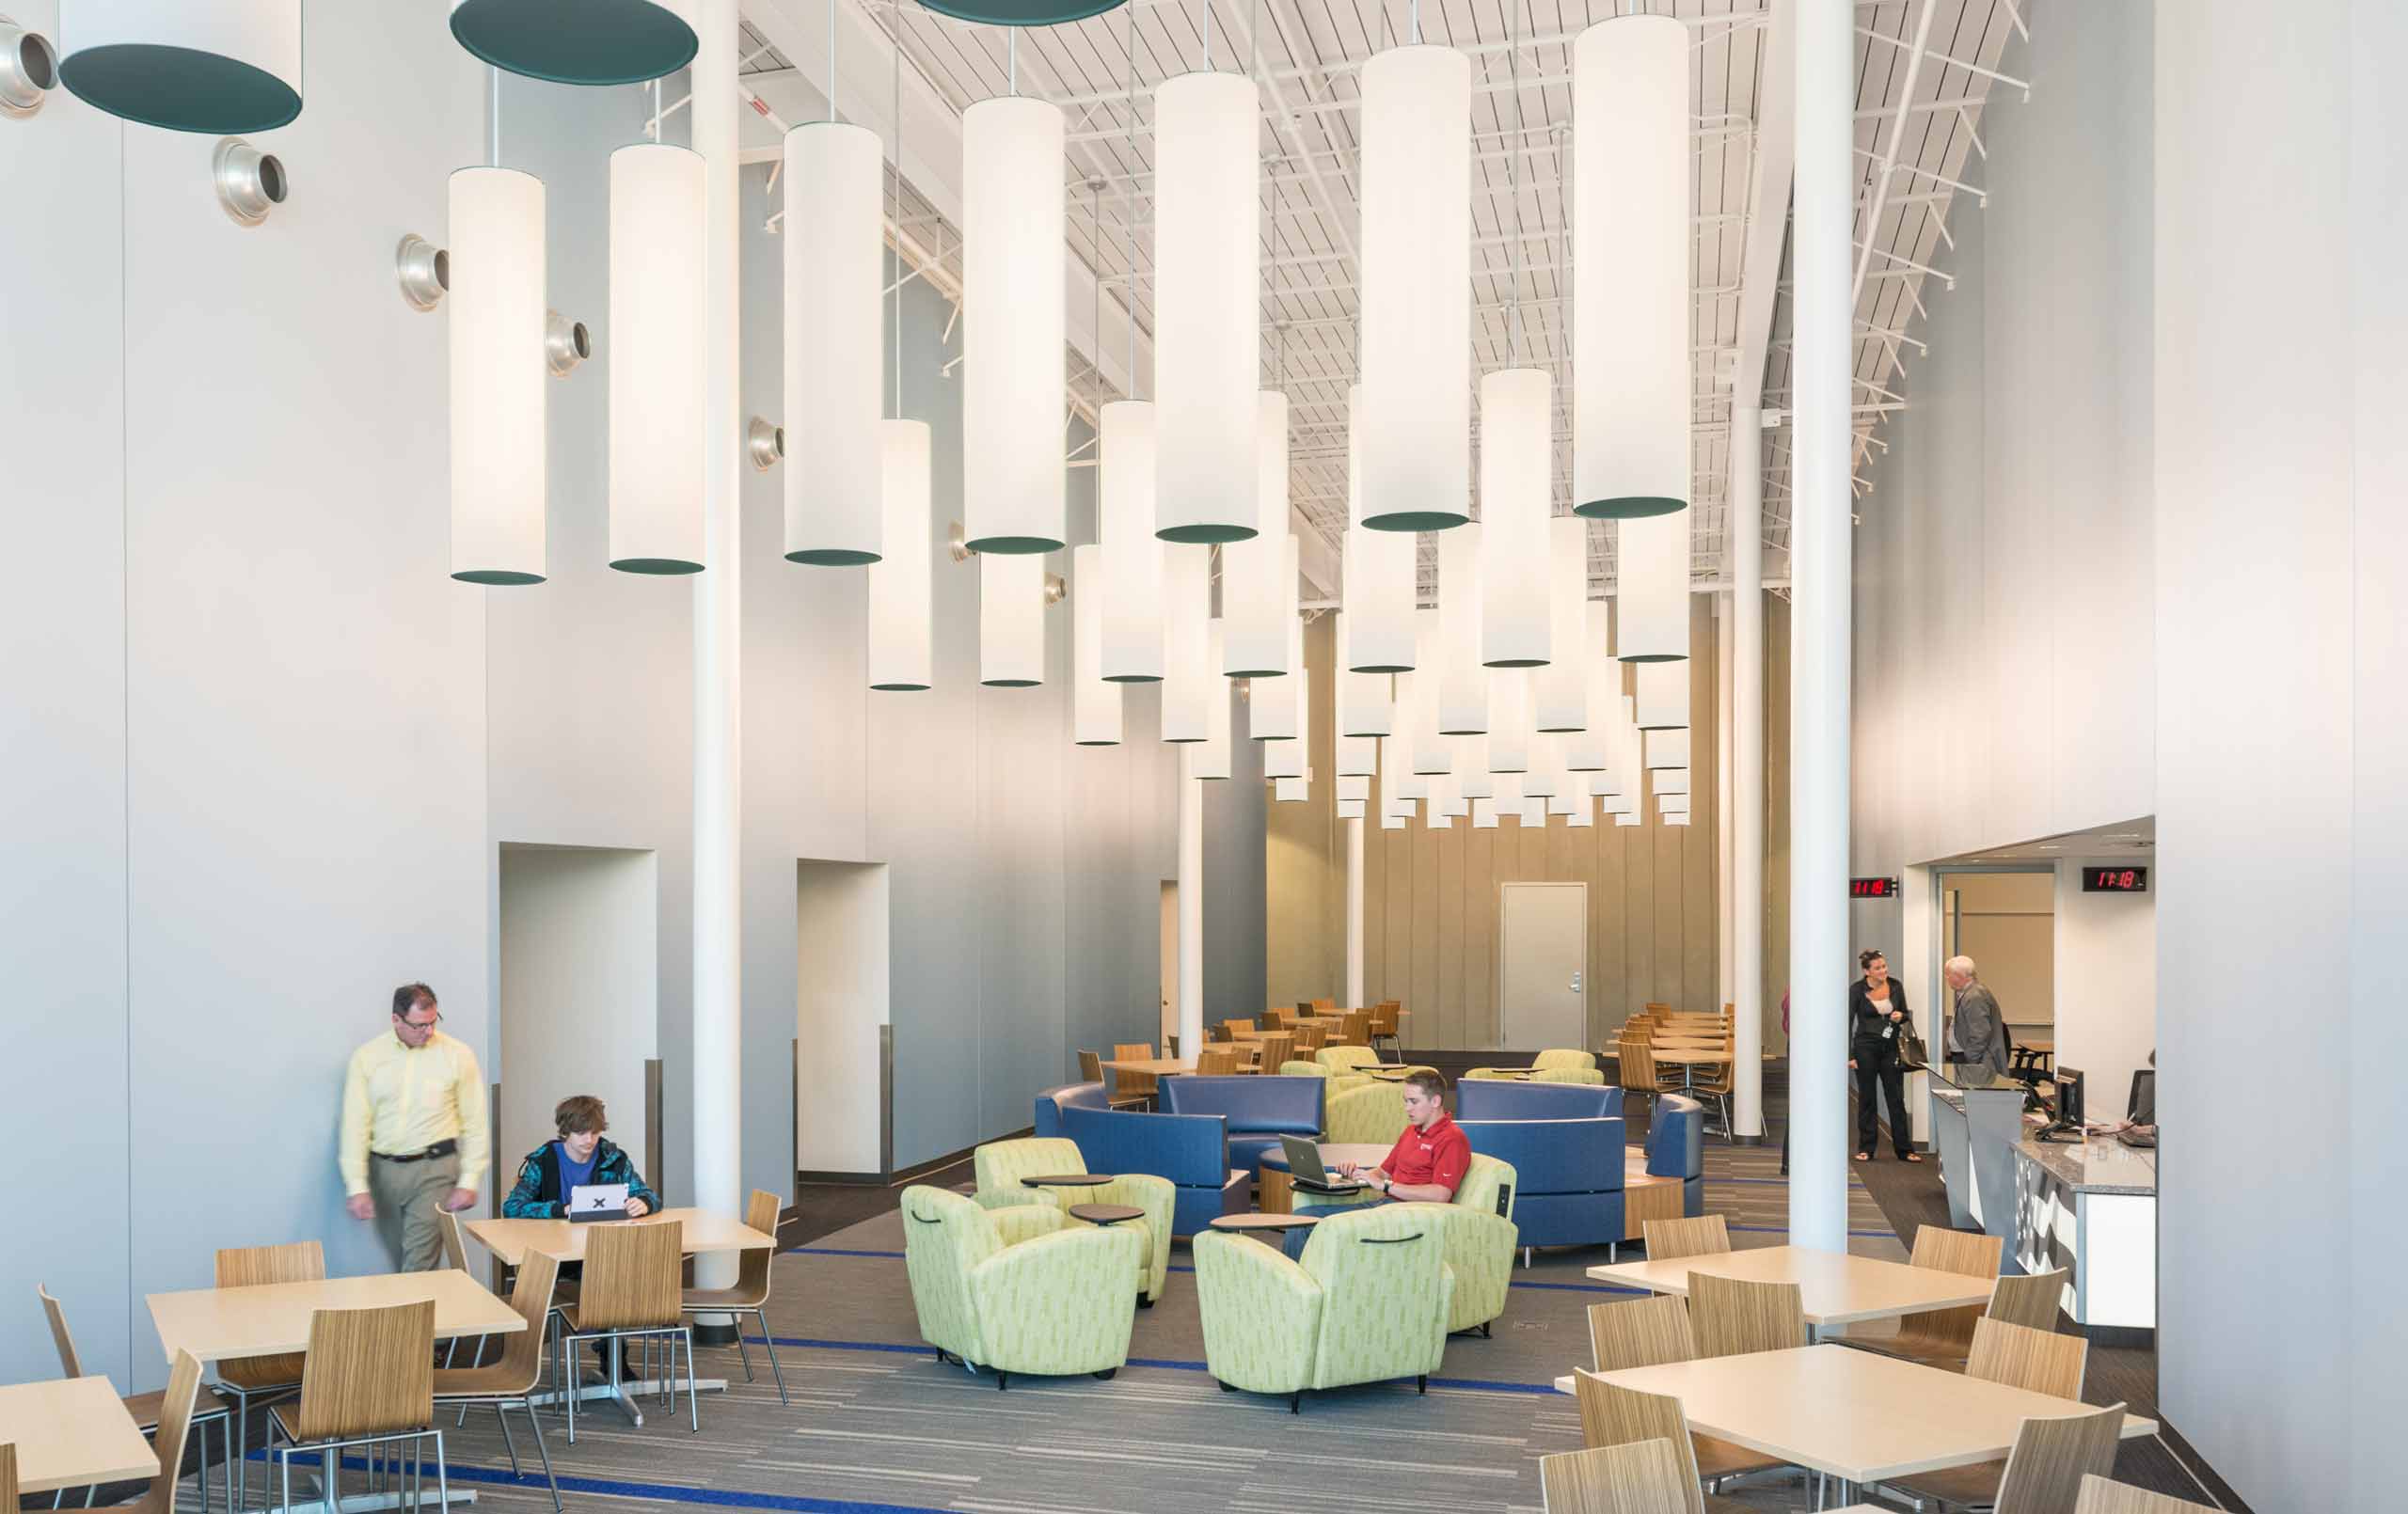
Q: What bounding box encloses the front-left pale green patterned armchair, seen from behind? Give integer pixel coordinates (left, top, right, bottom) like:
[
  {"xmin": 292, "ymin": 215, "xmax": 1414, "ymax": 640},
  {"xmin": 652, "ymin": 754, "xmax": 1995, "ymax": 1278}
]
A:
[{"xmin": 903, "ymin": 1184, "xmax": 1147, "ymax": 1389}]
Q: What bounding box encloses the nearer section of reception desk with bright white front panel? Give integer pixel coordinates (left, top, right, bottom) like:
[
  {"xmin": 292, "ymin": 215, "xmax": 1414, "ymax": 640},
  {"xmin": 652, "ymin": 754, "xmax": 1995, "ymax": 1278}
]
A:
[{"xmin": 2011, "ymin": 1136, "xmax": 2158, "ymax": 1343}]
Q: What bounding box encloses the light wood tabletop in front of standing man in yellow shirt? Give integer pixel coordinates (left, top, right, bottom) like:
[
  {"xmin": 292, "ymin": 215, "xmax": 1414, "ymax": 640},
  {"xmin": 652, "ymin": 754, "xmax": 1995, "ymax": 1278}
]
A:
[{"xmin": 150, "ymin": 1269, "xmax": 528, "ymax": 1363}]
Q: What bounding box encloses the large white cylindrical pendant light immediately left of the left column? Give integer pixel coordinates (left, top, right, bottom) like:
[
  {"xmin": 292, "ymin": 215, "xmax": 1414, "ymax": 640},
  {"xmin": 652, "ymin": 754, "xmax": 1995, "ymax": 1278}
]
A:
[{"xmin": 607, "ymin": 142, "xmax": 703, "ymax": 573}]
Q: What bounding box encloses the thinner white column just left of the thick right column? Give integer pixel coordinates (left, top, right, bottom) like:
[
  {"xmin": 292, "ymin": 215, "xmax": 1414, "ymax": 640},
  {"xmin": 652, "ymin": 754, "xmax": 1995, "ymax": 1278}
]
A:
[{"xmin": 1724, "ymin": 404, "xmax": 1797, "ymax": 1141}]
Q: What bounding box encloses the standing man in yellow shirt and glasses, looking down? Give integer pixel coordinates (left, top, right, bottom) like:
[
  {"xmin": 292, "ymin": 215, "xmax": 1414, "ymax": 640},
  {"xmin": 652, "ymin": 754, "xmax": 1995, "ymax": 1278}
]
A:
[{"xmin": 342, "ymin": 982, "xmax": 491, "ymax": 1273}]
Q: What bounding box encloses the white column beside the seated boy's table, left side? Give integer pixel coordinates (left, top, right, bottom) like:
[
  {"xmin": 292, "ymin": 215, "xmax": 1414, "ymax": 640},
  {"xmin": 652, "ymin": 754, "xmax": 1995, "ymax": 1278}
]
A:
[{"xmin": 689, "ymin": 0, "xmax": 744, "ymax": 1287}]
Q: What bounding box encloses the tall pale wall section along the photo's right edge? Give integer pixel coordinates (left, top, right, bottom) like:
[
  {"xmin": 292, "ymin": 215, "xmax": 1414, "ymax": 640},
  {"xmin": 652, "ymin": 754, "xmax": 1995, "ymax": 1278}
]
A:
[{"xmin": 2153, "ymin": 0, "xmax": 2408, "ymax": 1509}]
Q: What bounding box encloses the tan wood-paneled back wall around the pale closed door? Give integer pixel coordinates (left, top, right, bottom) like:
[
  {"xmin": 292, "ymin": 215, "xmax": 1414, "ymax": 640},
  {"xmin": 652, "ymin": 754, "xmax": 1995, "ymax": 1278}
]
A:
[{"xmin": 1264, "ymin": 594, "xmax": 1743, "ymax": 1047}]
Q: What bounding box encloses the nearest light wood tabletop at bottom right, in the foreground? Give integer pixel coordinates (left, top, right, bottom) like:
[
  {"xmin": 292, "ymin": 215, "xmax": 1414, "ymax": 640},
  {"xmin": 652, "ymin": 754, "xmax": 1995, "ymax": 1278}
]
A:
[{"xmin": 1556, "ymin": 1346, "xmax": 2158, "ymax": 1500}]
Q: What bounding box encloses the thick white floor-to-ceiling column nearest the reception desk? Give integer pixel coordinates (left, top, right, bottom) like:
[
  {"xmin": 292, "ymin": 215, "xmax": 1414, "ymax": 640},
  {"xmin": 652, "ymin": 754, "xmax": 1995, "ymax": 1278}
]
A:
[{"xmin": 1800, "ymin": 0, "xmax": 1857, "ymax": 1252}]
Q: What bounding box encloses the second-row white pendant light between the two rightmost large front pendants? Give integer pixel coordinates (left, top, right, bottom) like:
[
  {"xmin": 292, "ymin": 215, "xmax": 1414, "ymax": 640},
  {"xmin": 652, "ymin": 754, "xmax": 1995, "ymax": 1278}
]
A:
[{"xmin": 1481, "ymin": 369, "xmax": 1550, "ymax": 667}]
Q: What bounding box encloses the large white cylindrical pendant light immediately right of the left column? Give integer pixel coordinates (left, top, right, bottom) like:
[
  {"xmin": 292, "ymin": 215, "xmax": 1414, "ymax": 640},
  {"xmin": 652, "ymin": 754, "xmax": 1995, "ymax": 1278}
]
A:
[{"xmin": 778, "ymin": 120, "xmax": 886, "ymax": 568}]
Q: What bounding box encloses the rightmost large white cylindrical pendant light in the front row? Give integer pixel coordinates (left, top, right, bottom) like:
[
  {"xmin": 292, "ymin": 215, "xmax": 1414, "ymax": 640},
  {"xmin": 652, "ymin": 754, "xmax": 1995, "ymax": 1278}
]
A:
[{"xmin": 1573, "ymin": 14, "xmax": 1695, "ymax": 520}]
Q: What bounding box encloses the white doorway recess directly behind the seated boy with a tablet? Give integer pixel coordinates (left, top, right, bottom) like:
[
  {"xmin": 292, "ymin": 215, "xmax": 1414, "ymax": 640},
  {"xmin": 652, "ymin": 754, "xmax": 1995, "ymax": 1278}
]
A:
[{"xmin": 486, "ymin": 844, "xmax": 659, "ymax": 1169}]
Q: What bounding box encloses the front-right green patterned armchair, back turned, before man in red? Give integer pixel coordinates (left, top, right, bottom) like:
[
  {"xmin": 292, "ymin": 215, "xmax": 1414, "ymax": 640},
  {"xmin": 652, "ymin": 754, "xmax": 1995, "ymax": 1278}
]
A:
[{"xmin": 1195, "ymin": 1204, "xmax": 1454, "ymax": 1412}]
